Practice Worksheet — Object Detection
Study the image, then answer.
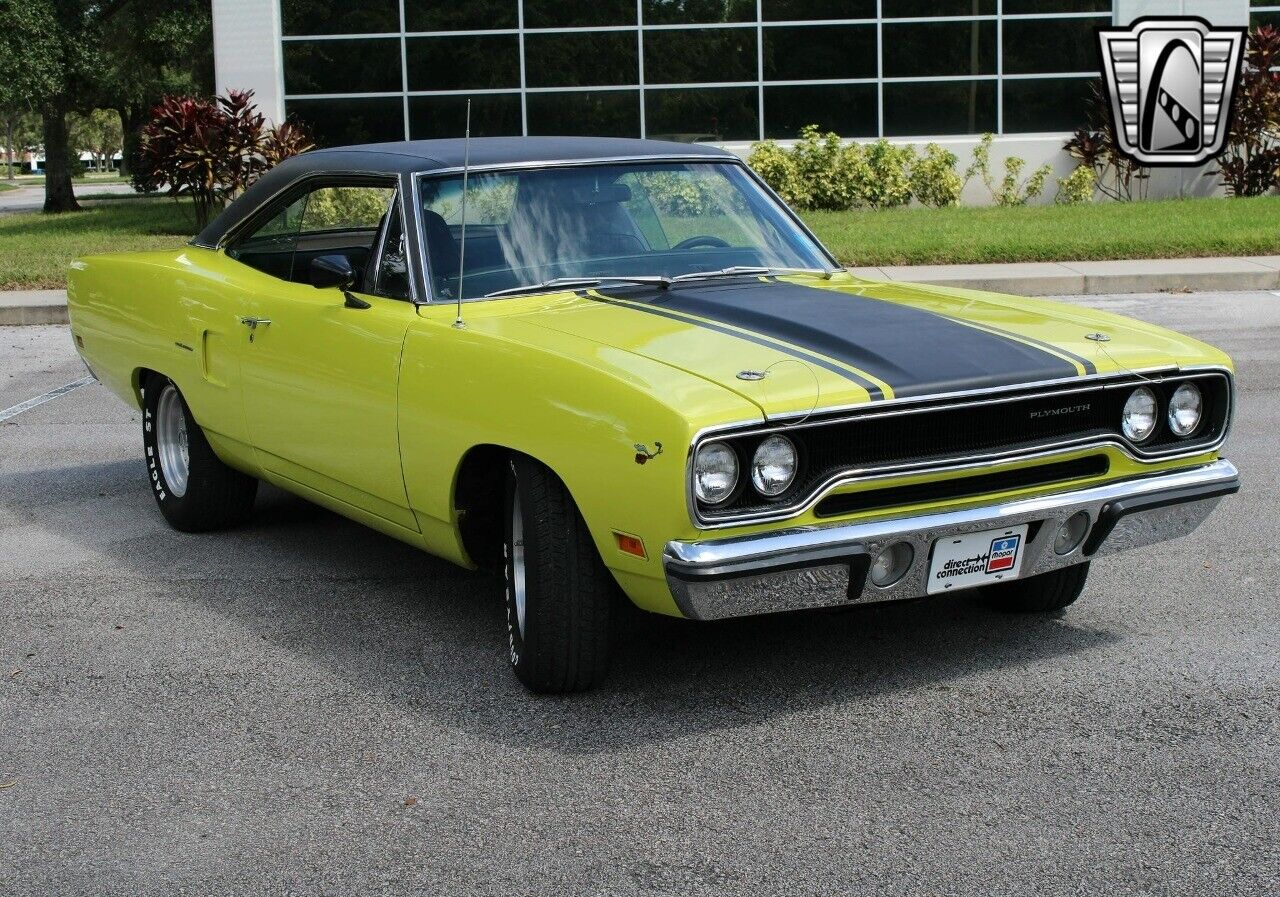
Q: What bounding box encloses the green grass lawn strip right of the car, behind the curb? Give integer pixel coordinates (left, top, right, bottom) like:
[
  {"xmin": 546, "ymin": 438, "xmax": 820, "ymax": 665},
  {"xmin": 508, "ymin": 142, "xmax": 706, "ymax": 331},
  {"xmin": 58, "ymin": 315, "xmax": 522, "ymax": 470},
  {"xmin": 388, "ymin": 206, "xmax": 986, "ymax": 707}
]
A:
[{"xmin": 804, "ymin": 196, "xmax": 1280, "ymax": 265}]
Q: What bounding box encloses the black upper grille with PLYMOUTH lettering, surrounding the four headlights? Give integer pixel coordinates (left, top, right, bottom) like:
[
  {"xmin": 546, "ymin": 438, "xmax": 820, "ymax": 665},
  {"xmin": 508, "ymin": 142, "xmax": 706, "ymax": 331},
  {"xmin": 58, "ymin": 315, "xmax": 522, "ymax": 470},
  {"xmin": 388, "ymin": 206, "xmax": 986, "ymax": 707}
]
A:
[{"xmin": 690, "ymin": 369, "xmax": 1233, "ymax": 526}]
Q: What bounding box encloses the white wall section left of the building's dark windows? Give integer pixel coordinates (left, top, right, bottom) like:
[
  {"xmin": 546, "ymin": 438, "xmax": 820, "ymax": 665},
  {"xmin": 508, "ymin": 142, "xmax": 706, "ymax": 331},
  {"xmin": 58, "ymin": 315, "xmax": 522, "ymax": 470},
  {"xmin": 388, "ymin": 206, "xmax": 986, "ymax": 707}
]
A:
[{"xmin": 212, "ymin": 0, "xmax": 284, "ymax": 123}]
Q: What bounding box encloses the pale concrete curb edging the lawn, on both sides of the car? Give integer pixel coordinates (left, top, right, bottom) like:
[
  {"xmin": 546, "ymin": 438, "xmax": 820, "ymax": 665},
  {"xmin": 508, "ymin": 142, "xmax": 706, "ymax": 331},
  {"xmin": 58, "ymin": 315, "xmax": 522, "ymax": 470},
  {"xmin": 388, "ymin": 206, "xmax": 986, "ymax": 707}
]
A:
[{"xmin": 0, "ymin": 256, "xmax": 1280, "ymax": 326}]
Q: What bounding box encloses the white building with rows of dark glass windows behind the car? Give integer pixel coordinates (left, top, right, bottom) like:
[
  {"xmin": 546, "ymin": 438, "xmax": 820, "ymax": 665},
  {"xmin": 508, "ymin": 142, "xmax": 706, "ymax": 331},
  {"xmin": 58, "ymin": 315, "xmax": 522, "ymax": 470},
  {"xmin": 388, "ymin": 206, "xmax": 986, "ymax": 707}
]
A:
[{"xmin": 212, "ymin": 0, "xmax": 1259, "ymax": 197}]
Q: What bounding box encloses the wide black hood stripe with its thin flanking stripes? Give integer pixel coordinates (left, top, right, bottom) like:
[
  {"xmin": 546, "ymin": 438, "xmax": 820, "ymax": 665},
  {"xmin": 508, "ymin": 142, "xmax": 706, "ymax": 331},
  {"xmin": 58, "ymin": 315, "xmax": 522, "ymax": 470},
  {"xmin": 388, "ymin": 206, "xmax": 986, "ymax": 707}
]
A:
[{"xmin": 596, "ymin": 280, "xmax": 1080, "ymax": 398}]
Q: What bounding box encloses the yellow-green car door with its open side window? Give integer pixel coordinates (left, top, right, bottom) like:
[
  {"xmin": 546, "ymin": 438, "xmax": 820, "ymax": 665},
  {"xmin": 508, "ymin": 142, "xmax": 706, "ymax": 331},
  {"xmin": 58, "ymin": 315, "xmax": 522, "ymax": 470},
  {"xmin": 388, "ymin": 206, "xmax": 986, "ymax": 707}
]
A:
[{"xmin": 222, "ymin": 182, "xmax": 417, "ymax": 531}]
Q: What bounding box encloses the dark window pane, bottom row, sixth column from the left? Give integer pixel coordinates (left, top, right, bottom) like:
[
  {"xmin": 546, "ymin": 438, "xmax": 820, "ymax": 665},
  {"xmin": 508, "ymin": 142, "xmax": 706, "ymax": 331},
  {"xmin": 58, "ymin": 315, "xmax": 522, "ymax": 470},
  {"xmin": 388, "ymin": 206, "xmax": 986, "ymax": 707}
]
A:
[{"xmin": 884, "ymin": 81, "xmax": 996, "ymax": 137}]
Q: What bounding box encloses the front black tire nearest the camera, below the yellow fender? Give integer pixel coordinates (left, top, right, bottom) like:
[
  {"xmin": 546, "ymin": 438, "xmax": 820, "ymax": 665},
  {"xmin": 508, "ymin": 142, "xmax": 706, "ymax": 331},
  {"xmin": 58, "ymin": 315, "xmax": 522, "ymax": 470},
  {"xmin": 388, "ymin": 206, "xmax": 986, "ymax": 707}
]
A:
[{"xmin": 502, "ymin": 457, "xmax": 617, "ymax": 694}]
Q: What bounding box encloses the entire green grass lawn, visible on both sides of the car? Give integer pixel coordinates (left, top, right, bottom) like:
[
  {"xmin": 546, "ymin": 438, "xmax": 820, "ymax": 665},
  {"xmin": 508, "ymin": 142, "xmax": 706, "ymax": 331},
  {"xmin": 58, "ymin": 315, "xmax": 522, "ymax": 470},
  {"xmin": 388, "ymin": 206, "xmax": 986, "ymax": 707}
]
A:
[{"xmin": 0, "ymin": 196, "xmax": 1280, "ymax": 289}]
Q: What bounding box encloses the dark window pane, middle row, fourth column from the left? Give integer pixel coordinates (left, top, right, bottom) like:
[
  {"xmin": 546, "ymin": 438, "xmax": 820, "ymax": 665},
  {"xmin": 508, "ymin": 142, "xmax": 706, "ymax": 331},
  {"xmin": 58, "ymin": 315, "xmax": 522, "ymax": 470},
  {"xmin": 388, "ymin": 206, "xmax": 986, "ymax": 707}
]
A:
[{"xmin": 644, "ymin": 28, "xmax": 756, "ymax": 84}]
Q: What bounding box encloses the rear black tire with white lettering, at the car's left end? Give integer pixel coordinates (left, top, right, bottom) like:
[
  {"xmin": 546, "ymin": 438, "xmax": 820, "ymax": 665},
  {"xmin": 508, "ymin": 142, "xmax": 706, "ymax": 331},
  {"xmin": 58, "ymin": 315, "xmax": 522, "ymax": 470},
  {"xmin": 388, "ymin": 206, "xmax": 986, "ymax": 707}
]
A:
[{"xmin": 142, "ymin": 375, "xmax": 257, "ymax": 532}]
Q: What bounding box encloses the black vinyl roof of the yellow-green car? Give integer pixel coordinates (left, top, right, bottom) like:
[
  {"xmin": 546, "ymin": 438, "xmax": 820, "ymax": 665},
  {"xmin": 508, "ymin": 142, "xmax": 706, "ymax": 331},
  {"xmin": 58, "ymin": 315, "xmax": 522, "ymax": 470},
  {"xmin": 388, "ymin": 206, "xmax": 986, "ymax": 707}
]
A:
[{"xmin": 192, "ymin": 137, "xmax": 737, "ymax": 247}]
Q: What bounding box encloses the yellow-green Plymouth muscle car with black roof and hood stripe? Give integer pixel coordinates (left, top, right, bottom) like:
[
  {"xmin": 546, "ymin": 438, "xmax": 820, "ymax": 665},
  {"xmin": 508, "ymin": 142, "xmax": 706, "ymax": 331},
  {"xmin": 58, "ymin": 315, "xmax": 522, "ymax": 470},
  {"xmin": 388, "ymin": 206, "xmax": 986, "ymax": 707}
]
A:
[{"xmin": 69, "ymin": 138, "xmax": 1238, "ymax": 691}]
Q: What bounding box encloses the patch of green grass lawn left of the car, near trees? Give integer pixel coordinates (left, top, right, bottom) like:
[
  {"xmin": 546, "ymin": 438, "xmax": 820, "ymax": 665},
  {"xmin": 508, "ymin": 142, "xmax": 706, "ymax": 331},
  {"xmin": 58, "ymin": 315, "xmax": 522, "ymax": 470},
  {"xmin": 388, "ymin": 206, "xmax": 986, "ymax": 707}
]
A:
[{"xmin": 0, "ymin": 198, "xmax": 196, "ymax": 289}]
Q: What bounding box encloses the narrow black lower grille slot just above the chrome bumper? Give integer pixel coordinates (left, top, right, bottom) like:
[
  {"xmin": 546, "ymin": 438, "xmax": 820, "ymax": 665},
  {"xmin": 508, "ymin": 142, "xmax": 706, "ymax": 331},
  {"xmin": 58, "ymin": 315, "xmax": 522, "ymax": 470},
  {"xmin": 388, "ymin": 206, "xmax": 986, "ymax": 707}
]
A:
[{"xmin": 814, "ymin": 454, "xmax": 1111, "ymax": 517}]
